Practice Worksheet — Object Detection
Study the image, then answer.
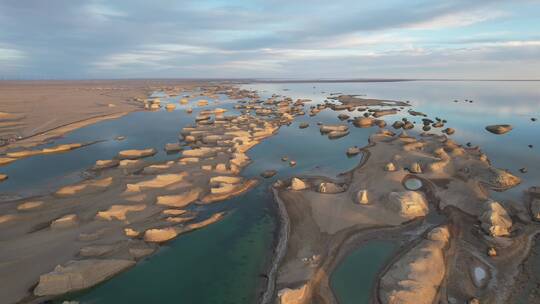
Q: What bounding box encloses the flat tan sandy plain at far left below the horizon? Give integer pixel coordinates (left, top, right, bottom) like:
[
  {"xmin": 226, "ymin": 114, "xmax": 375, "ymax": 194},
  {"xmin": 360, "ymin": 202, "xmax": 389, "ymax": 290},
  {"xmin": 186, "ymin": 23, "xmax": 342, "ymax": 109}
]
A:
[{"xmin": 0, "ymin": 80, "xmax": 204, "ymax": 152}]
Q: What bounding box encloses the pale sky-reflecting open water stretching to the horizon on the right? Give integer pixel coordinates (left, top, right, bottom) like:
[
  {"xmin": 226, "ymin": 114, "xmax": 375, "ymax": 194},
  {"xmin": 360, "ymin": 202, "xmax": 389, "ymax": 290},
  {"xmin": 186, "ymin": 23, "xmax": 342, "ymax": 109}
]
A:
[{"xmin": 245, "ymin": 81, "xmax": 540, "ymax": 200}]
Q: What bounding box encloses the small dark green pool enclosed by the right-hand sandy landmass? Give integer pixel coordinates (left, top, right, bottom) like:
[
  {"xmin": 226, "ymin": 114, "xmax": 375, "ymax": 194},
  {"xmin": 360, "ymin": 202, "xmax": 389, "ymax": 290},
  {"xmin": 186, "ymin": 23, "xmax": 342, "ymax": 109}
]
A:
[{"xmin": 330, "ymin": 240, "xmax": 397, "ymax": 304}]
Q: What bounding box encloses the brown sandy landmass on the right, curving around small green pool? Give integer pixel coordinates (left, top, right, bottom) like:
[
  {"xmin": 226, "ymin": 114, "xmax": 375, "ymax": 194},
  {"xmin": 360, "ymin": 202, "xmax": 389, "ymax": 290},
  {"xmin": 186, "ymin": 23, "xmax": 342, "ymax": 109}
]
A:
[{"xmin": 274, "ymin": 119, "xmax": 538, "ymax": 304}]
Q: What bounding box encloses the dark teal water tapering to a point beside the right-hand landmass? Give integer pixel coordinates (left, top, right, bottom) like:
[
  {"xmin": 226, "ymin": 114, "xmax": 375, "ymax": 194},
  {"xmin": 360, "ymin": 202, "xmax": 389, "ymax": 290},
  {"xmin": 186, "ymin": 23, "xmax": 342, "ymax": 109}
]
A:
[{"xmin": 68, "ymin": 186, "xmax": 276, "ymax": 304}]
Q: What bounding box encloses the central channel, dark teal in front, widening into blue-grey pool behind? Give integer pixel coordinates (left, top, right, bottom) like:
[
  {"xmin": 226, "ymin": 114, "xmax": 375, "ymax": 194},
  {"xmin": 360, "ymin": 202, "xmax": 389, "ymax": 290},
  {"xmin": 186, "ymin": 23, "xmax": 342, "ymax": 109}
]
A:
[{"xmin": 56, "ymin": 89, "xmax": 369, "ymax": 304}]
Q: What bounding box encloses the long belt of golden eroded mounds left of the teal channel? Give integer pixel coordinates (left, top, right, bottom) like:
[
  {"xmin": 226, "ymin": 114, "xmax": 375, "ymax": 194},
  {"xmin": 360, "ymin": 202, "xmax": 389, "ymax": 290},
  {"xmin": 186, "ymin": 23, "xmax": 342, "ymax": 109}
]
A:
[{"xmin": 0, "ymin": 85, "xmax": 314, "ymax": 303}]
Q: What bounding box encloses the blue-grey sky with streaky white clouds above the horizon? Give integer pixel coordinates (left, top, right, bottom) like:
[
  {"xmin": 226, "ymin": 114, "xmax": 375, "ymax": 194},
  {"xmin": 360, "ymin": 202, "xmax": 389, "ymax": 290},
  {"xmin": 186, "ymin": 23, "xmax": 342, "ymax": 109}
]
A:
[{"xmin": 0, "ymin": 0, "xmax": 540, "ymax": 79}]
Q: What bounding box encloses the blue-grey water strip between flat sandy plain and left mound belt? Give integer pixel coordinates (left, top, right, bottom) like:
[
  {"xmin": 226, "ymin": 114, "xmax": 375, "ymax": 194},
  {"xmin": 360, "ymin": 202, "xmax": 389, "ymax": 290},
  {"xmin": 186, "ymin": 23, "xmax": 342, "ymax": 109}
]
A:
[{"xmin": 0, "ymin": 96, "xmax": 234, "ymax": 196}]
